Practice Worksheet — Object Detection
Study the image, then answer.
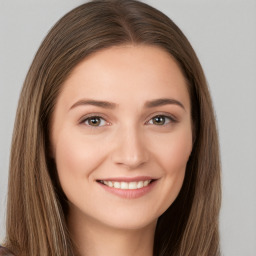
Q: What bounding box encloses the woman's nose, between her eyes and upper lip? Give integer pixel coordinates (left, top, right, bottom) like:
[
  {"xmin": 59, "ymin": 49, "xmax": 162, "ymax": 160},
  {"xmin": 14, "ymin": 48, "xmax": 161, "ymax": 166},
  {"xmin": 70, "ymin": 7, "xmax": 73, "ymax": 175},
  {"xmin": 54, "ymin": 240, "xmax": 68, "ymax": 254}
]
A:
[{"xmin": 112, "ymin": 125, "xmax": 149, "ymax": 169}]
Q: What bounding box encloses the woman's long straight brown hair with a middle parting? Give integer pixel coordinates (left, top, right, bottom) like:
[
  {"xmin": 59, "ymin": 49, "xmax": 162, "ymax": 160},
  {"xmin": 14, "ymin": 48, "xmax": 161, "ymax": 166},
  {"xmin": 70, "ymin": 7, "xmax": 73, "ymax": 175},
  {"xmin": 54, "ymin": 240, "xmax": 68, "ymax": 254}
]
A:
[{"xmin": 5, "ymin": 0, "xmax": 221, "ymax": 256}]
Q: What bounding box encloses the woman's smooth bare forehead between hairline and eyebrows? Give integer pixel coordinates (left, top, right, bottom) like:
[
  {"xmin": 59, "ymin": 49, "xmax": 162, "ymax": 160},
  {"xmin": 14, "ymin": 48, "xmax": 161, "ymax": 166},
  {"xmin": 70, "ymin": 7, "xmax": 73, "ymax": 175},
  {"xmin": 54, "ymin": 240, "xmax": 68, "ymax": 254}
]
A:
[{"xmin": 57, "ymin": 45, "xmax": 189, "ymax": 111}]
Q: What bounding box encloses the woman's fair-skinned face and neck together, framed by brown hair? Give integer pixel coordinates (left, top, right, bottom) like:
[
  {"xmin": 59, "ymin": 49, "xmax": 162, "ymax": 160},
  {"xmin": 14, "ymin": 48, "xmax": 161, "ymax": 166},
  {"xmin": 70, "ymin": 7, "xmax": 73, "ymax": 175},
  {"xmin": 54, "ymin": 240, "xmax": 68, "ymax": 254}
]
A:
[{"xmin": 51, "ymin": 45, "xmax": 192, "ymax": 256}]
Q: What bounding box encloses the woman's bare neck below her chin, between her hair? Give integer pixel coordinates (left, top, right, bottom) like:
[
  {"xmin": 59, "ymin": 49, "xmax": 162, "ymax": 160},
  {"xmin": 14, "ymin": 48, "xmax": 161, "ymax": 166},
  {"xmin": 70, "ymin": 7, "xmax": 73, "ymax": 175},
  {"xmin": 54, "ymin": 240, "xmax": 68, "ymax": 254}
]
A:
[{"xmin": 68, "ymin": 208, "xmax": 156, "ymax": 256}]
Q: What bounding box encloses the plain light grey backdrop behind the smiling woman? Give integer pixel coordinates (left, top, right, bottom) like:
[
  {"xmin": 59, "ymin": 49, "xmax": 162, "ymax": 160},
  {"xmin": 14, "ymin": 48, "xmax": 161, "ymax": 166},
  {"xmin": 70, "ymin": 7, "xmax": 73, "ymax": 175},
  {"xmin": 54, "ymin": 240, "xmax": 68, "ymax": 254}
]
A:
[{"xmin": 0, "ymin": 0, "xmax": 256, "ymax": 256}]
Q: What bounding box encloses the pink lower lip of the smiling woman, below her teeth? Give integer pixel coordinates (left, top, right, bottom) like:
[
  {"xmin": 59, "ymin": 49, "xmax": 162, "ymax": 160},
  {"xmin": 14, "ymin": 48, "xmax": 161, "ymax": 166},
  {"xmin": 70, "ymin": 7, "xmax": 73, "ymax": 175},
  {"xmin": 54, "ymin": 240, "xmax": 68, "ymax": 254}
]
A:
[{"xmin": 98, "ymin": 180, "xmax": 157, "ymax": 199}]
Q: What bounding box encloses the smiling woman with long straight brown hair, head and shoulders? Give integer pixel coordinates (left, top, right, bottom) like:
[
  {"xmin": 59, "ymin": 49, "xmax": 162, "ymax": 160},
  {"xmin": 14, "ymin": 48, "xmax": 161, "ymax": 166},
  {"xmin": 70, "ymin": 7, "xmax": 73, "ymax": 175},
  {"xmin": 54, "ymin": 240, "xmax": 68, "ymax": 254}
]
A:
[{"xmin": 2, "ymin": 0, "xmax": 220, "ymax": 256}]
